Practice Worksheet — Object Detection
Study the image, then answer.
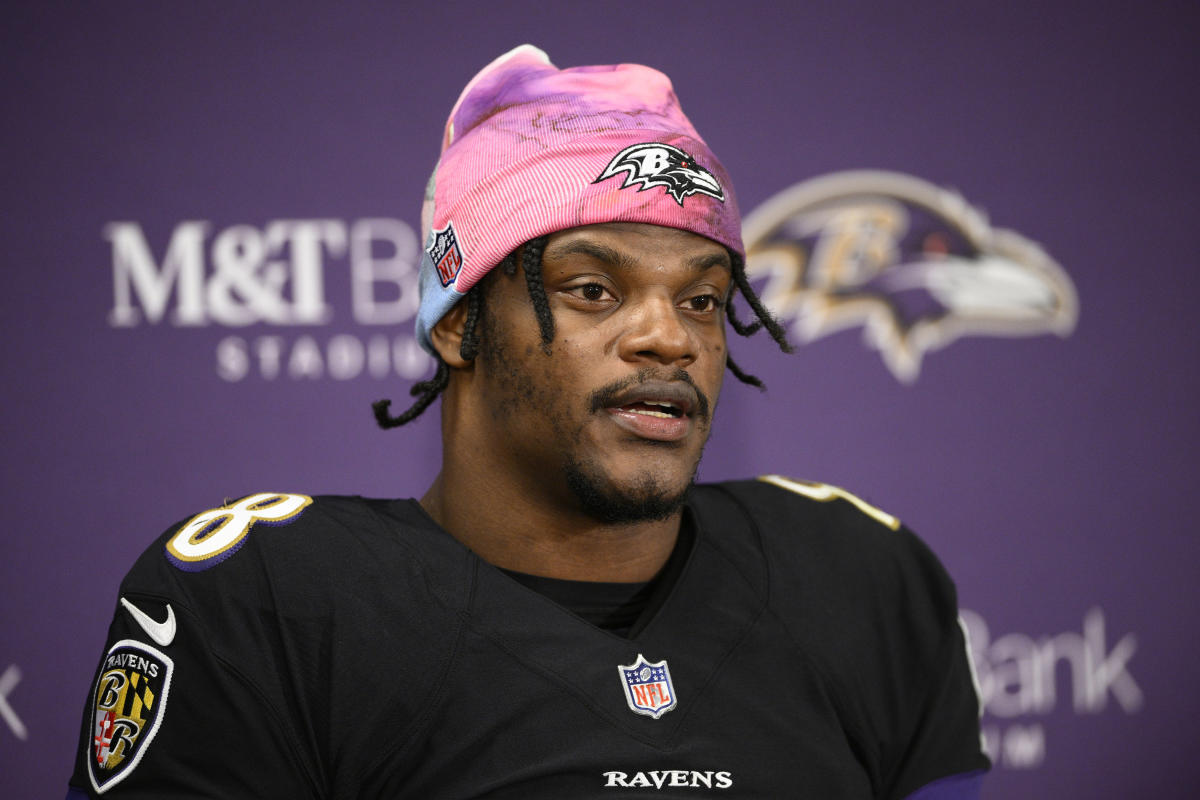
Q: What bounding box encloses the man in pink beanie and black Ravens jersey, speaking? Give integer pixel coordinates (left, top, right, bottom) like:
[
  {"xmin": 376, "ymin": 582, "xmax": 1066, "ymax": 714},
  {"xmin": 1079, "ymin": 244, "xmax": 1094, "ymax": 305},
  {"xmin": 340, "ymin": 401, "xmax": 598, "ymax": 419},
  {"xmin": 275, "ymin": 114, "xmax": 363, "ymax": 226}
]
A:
[{"xmin": 71, "ymin": 46, "xmax": 988, "ymax": 799}]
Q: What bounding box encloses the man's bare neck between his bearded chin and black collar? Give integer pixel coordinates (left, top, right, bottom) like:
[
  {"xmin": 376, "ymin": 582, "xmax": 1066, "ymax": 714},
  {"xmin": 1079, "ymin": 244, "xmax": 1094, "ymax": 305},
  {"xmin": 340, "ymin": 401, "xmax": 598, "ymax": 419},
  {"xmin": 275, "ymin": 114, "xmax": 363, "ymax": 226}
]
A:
[{"xmin": 420, "ymin": 463, "xmax": 682, "ymax": 583}]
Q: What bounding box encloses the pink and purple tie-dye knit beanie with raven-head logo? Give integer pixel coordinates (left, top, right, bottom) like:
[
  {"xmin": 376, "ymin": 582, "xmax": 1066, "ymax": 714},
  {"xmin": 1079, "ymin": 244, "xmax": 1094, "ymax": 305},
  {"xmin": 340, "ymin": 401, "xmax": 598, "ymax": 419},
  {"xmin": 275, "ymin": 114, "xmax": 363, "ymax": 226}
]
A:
[{"xmin": 416, "ymin": 44, "xmax": 744, "ymax": 353}]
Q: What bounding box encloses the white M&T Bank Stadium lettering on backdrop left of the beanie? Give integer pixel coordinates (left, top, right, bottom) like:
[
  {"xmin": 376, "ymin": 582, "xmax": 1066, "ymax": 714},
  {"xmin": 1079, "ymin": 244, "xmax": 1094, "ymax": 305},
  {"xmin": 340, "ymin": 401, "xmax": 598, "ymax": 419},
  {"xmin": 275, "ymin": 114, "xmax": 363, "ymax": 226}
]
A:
[{"xmin": 103, "ymin": 218, "xmax": 430, "ymax": 380}]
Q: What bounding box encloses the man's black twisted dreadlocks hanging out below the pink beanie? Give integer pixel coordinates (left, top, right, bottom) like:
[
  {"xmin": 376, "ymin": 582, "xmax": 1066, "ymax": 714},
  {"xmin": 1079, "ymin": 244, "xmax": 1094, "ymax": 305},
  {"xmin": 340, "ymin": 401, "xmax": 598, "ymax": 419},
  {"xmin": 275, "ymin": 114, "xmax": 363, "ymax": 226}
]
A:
[{"xmin": 371, "ymin": 236, "xmax": 792, "ymax": 429}]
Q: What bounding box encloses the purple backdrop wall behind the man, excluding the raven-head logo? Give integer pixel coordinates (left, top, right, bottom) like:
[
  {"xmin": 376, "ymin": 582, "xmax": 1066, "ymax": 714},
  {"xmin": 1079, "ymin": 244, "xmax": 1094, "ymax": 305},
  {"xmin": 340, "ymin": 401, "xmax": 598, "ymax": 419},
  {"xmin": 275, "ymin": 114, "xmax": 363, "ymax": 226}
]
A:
[{"xmin": 0, "ymin": 0, "xmax": 1200, "ymax": 798}]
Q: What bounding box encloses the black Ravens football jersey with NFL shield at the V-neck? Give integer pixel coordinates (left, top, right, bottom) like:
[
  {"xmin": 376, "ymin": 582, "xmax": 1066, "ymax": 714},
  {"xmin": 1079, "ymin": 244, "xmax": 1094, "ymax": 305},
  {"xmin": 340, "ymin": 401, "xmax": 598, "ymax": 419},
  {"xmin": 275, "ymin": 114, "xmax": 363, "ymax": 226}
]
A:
[{"xmin": 71, "ymin": 477, "xmax": 988, "ymax": 800}]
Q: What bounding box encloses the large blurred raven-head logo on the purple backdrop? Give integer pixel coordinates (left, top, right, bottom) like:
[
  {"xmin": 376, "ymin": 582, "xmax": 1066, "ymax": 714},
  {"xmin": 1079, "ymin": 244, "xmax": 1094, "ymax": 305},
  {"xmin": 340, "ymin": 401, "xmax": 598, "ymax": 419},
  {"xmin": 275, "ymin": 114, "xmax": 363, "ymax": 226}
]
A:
[{"xmin": 743, "ymin": 170, "xmax": 1079, "ymax": 383}]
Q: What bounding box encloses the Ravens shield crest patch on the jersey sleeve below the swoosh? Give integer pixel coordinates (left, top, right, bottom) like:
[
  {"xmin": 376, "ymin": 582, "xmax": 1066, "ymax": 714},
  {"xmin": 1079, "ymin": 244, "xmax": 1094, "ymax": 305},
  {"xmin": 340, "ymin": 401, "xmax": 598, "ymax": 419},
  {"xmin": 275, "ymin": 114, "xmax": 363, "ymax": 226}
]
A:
[{"xmin": 88, "ymin": 639, "xmax": 174, "ymax": 794}]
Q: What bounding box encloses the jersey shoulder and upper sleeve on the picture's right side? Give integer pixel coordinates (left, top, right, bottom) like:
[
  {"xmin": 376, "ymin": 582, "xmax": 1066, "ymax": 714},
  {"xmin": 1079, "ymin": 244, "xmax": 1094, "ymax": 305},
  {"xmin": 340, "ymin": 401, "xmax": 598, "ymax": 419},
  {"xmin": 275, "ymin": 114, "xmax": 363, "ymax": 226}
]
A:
[{"xmin": 712, "ymin": 475, "xmax": 988, "ymax": 796}]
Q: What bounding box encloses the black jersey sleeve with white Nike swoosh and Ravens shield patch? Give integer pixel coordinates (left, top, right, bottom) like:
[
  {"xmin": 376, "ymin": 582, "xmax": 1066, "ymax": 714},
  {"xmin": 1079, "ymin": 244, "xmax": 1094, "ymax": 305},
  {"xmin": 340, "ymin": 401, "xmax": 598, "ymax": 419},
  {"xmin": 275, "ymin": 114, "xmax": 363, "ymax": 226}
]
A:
[{"xmin": 68, "ymin": 585, "xmax": 318, "ymax": 799}]
